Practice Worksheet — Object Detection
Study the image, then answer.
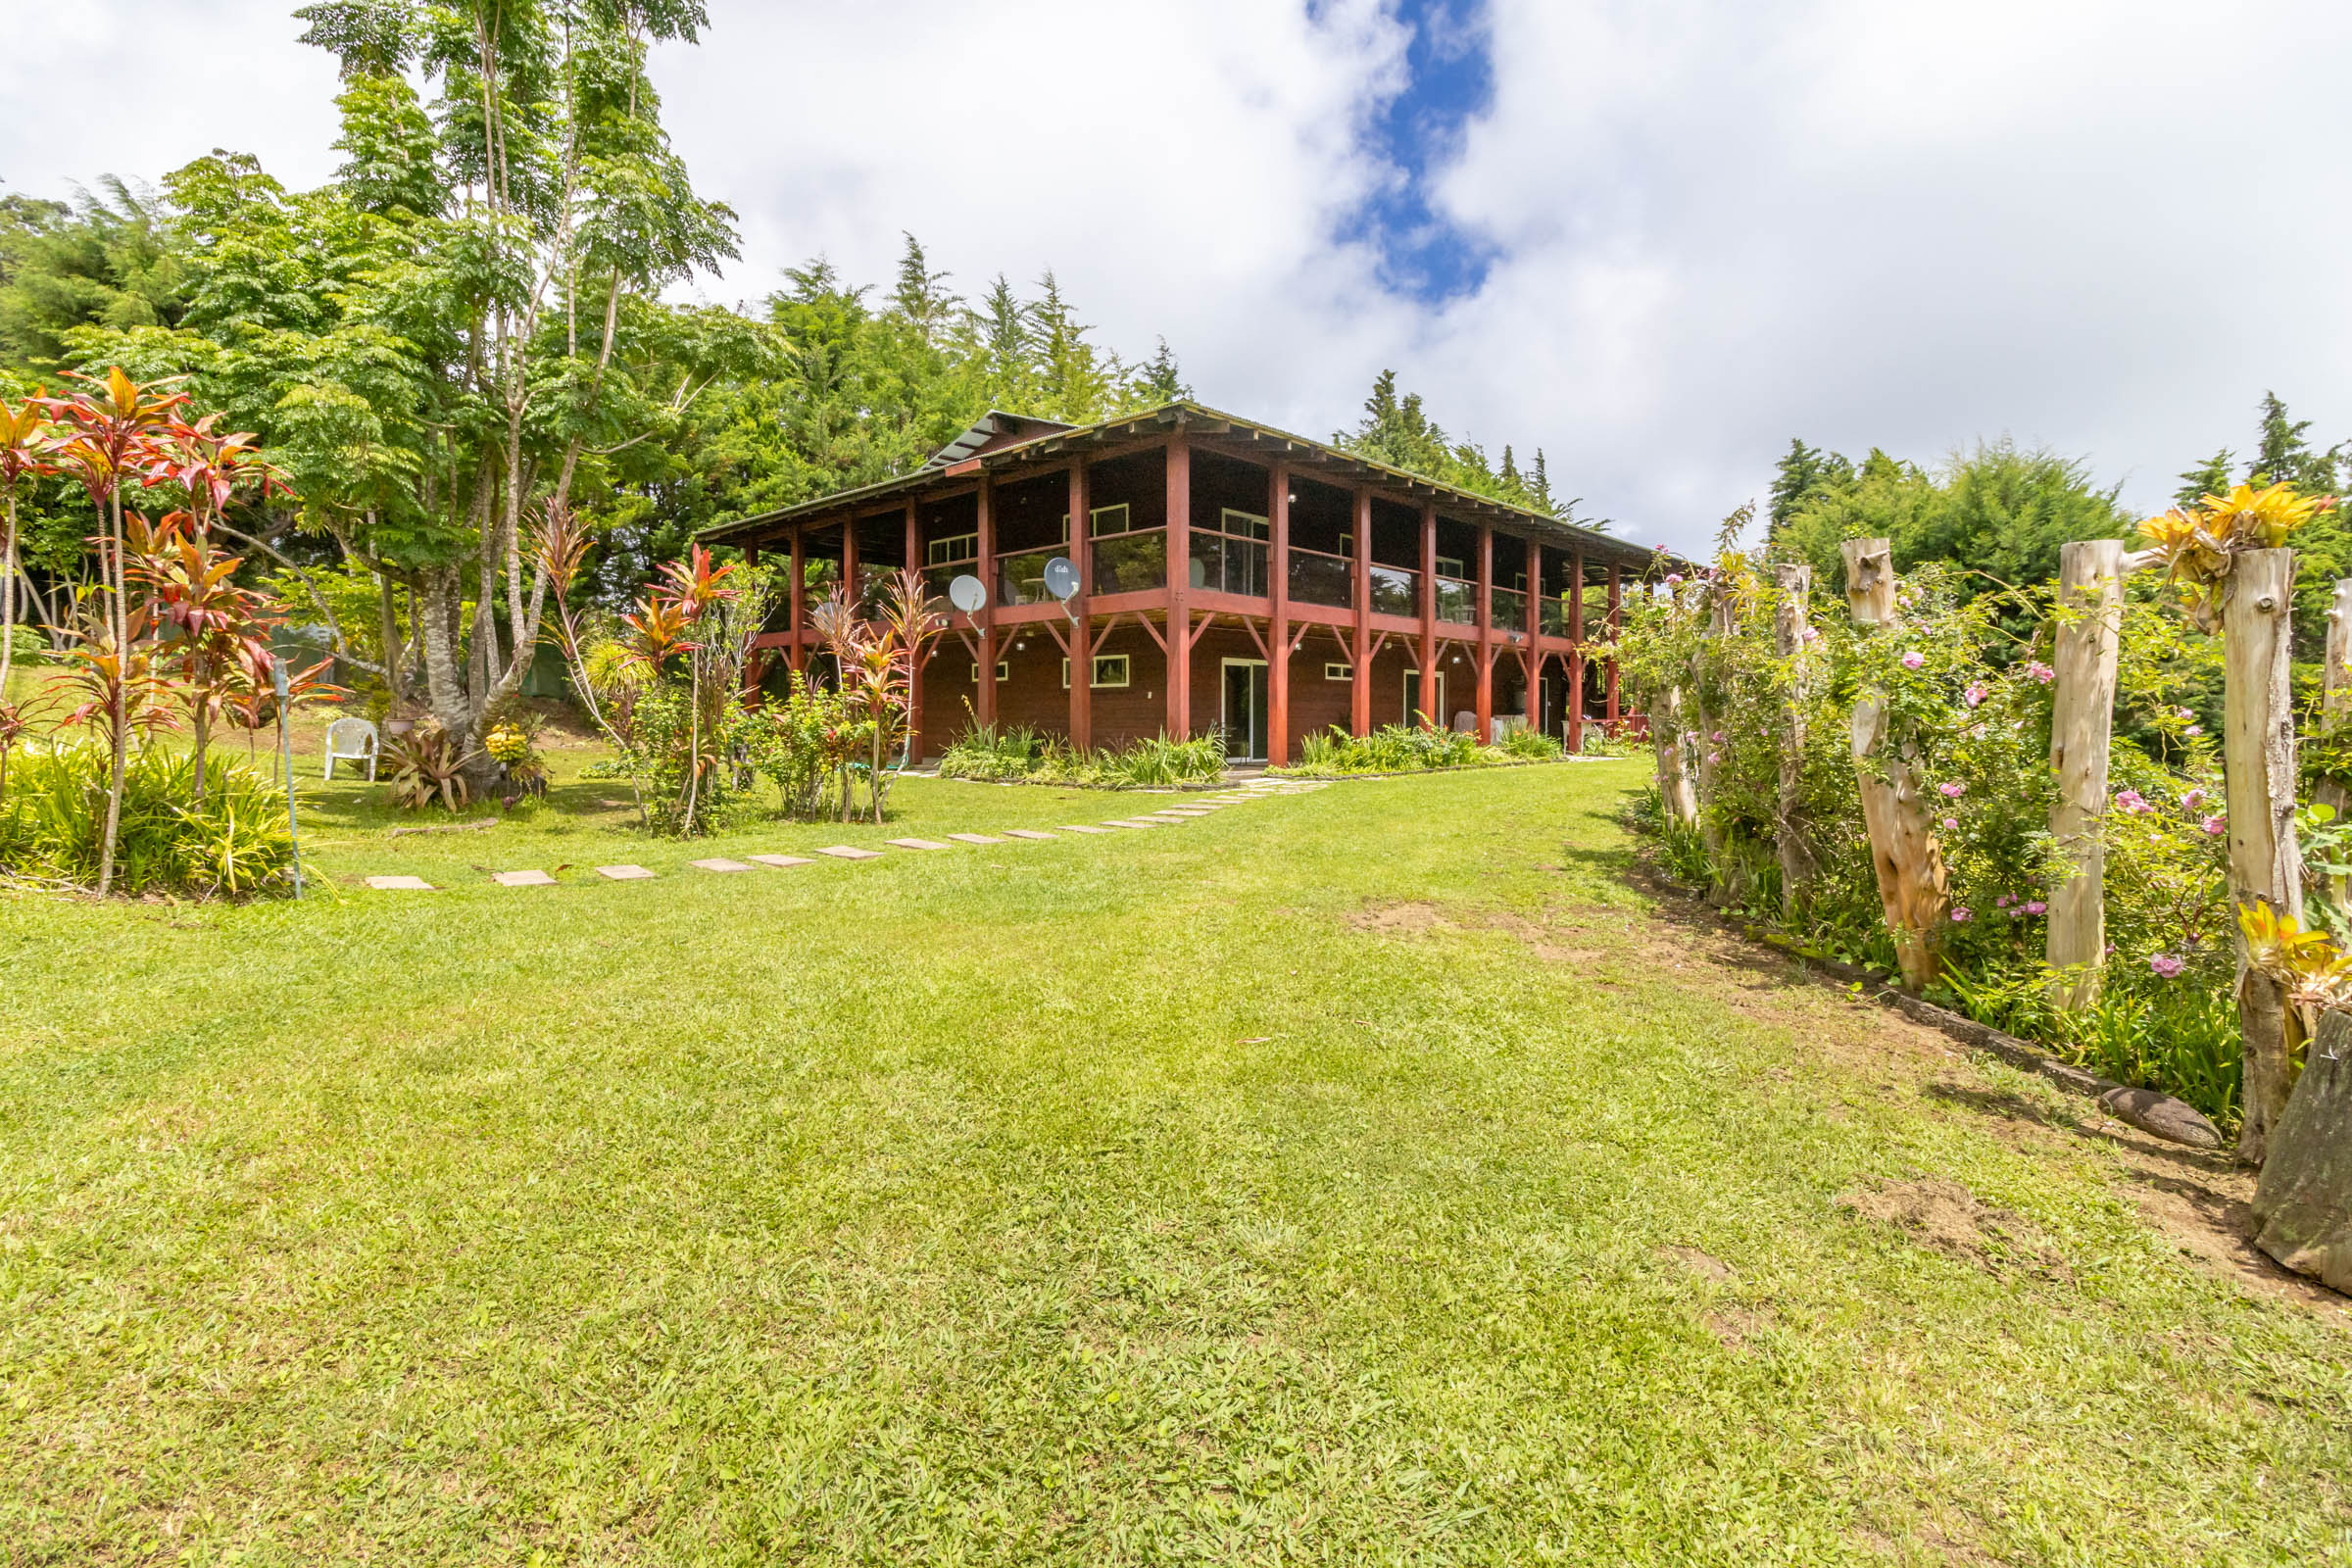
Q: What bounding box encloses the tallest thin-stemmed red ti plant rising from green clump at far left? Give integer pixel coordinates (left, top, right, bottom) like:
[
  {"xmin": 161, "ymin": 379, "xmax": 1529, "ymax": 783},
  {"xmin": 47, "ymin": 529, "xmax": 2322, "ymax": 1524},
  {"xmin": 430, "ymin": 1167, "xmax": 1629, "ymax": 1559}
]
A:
[{"xmin": 45, "ymin": 365, "xmax": 188, "ymax": 898}]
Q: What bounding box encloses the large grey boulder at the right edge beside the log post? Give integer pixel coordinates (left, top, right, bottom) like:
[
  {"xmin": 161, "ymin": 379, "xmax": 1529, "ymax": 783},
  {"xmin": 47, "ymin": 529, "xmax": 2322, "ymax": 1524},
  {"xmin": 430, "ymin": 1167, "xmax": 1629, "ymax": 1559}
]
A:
[{"xmin": 2253, "ymin": 1013, "xmax": 2352, "ymax": 1296}]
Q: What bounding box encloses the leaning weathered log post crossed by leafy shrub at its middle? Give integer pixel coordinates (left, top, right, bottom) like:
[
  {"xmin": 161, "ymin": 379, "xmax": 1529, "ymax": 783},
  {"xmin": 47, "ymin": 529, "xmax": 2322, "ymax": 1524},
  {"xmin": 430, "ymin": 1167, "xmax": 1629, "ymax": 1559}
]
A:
[{"xmin": 1839, "ymin": 538, "xmax": 1950, "ymax": 990}]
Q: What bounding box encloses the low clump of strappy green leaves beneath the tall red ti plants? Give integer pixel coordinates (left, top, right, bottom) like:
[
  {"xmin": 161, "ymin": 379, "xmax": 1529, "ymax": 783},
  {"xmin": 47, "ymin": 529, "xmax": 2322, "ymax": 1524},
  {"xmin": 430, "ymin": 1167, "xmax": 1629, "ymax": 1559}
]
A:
[{"xmin": 0, "ymin": 743, "xmax": 294, "ymax": 898}]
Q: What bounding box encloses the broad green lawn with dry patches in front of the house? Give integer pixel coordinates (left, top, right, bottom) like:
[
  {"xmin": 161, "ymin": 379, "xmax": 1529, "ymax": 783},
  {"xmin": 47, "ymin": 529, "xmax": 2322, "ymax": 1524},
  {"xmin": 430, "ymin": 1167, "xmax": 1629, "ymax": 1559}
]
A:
[{"xmin": 0, "ymin": 757, "xmax": 2352, "ymax": 1563}]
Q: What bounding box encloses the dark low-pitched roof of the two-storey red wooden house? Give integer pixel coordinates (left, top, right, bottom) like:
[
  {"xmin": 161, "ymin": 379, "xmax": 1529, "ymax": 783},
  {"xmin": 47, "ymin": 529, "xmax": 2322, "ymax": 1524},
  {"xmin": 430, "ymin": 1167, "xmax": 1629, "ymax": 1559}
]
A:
[{"xmin": 696, "ymin": 402, "xmax": 1682, "ymax": 566}]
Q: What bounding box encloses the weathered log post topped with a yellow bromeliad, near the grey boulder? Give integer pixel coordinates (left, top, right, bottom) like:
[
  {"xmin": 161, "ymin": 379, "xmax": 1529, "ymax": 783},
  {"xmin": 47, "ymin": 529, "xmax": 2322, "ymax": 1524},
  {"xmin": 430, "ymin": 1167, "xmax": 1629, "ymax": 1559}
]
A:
[{"xmin": 2221, "ymin": 550, "xmax": 2303, "ymax": 1166}]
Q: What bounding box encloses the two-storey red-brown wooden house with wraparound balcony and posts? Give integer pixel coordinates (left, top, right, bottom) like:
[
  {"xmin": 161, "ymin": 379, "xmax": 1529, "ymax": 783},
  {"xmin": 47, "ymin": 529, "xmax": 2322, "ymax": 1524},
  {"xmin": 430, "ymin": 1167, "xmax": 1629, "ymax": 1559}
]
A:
[{"xmin": 704, "ymin": 402, "xmax": 1658, "ymax": 764}]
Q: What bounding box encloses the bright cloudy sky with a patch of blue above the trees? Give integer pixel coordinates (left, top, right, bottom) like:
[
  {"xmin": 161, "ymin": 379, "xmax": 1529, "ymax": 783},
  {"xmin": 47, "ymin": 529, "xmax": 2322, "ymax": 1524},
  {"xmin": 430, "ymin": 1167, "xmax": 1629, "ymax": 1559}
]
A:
[{"xmin": 0, "ymin": 0, "xmax": 2352, "ymax": 550}]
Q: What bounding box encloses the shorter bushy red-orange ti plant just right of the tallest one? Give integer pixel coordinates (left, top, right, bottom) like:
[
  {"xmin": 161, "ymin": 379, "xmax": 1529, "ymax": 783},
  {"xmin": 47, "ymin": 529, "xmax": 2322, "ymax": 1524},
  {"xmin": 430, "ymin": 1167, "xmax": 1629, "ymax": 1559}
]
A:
[{"xmin": 124, "ymin": 513, "xmax": 280, "ymax": 804}]
